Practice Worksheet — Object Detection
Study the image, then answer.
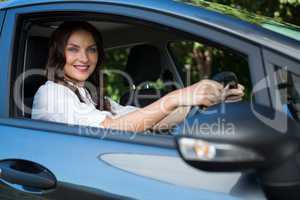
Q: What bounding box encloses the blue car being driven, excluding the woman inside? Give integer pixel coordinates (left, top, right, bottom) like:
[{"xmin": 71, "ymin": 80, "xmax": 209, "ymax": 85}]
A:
[{"xmin": 0, "ymin": 0, "xmax": 300, "ymax": 200}]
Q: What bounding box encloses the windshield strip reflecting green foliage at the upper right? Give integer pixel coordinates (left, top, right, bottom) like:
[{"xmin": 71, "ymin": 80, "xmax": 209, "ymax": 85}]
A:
[{"xmin": 175, "ymin": 0, "xmax": 300, "ymax": 41}]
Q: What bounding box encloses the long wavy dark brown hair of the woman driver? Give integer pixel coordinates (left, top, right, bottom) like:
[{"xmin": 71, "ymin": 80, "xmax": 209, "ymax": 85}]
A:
[{"xmin": 46, "ymin": 21, "xmax": 111, "ymax": 111}]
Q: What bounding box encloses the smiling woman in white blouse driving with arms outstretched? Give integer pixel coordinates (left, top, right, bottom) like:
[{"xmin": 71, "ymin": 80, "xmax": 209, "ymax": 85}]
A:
[{"xmin": 32, "ymin": 22, "xmax": 244, "ymax": 131}]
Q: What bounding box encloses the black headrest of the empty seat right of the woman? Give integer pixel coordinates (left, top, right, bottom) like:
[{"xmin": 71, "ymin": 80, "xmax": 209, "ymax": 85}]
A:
[{"xmin": 126, "ymin": 44, "xmax": 162, "ymax": 85}]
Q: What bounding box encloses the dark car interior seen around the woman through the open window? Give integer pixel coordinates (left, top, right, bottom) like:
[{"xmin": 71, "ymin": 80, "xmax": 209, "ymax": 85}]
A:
[{"xmin": 10, "ymin": 13, "xmax": 251, "ymax": 132}]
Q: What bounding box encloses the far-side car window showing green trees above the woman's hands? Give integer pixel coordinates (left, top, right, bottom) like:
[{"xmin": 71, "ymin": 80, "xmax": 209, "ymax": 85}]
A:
[{"xmin": 169, "ymin": 40, "xmax": 252, "ymax": 99}]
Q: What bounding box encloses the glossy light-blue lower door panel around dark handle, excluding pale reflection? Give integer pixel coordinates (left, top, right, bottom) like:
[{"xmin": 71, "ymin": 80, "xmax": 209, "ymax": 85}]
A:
[{"xmin": 0, "ymin": 126, "xmax": 244, "ymax": 200}]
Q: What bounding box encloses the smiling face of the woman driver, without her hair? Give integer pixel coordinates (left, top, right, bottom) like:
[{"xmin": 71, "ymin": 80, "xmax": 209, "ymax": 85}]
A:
[{"xmin": 64, "ymin": 30, "xmax": 98, "ymax": 85}]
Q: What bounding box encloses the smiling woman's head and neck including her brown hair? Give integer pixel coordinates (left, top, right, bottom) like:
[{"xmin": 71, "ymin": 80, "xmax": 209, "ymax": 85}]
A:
[{"xmin": 46, "ymin": 22, "xmax": 104, "ymax": 106}]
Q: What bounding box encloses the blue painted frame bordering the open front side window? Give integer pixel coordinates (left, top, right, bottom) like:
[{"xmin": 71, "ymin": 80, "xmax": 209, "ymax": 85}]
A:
[{"xmin": 0, "ymin": 2, "xmax": 269, "ymax": 145}]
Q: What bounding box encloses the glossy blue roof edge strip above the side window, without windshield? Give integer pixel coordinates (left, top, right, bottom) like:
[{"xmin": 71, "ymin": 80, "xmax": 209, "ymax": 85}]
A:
[{"xmin": 0, "ymin": 0, "xmax": 300, "ymax": 60}]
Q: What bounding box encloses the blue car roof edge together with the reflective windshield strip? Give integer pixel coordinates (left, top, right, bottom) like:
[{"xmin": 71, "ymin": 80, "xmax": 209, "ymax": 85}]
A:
[{"xmin": 0, "ymin": 0, "xmax": 300, "ymax": 60}]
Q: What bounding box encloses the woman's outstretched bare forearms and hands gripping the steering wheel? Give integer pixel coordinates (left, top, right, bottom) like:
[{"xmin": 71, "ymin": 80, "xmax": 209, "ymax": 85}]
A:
[{"xmin": 101, "ymin": 80, "xmax": 243, "ymax": 131}]
